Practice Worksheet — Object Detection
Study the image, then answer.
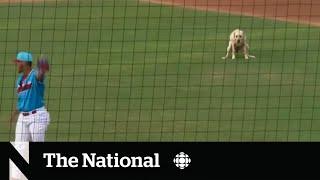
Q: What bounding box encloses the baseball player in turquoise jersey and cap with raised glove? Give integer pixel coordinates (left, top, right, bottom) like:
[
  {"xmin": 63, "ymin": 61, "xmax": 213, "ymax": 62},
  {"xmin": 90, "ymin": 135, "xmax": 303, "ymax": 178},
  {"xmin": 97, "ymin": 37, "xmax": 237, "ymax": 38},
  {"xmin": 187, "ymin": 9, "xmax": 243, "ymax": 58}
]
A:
[{"xmin": 11, "ymin": 52, "xmax": 50, "ymax": 179}]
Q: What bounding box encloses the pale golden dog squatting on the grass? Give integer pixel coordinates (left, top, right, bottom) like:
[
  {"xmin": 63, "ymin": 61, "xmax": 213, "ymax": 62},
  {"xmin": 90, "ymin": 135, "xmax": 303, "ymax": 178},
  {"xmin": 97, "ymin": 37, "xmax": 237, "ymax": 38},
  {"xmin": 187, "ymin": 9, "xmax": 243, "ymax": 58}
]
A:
[{"xmin": 222, "ymin": 29, "xmax": 256, "ymax": 59}]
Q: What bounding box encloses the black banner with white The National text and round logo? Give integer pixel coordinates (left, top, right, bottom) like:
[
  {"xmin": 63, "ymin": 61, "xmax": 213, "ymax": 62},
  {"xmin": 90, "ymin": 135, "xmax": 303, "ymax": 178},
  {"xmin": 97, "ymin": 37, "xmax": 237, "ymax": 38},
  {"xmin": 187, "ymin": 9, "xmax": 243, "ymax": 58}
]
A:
[{"xmin": 1, "ymin": 142, "xmax": 320, "ymax": 180}]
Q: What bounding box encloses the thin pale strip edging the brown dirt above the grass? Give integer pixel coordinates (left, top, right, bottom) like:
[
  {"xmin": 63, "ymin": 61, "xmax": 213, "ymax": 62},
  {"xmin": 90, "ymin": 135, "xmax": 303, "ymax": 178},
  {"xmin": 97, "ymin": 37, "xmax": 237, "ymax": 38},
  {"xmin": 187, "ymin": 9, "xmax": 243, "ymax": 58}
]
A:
[{"xmin": 140, "ymin": 0, "xmax": 320, "ymax": 27}]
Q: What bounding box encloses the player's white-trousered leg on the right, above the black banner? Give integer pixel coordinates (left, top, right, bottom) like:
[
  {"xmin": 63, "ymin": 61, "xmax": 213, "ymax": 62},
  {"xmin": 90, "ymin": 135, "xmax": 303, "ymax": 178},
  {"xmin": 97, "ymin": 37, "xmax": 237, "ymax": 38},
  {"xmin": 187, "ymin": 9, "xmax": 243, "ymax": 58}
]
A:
[{"xmin": 29, "ymin": 111, "xmax": 50, "ymax": 142}]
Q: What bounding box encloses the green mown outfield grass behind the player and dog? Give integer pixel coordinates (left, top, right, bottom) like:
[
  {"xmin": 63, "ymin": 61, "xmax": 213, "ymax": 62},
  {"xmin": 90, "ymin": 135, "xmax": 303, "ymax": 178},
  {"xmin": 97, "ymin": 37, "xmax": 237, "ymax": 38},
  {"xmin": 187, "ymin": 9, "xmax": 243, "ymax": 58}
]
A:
[{"xmin": 0, "ymin": 0, "xmax": 320, "ymax": 141}]
